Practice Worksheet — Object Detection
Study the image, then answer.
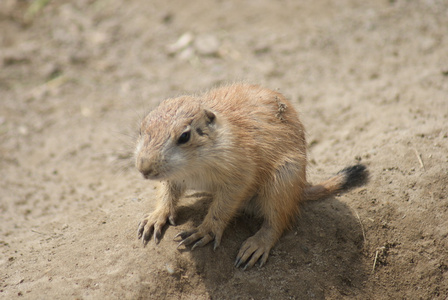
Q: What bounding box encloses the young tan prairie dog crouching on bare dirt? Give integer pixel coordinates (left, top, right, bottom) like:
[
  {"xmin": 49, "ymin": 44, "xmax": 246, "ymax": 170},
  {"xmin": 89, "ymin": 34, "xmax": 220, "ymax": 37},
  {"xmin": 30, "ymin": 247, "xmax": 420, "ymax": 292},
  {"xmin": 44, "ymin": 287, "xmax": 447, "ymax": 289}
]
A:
[{"xmin": 135, "ymin": 84, "xmax": 367, "ymax": 269}]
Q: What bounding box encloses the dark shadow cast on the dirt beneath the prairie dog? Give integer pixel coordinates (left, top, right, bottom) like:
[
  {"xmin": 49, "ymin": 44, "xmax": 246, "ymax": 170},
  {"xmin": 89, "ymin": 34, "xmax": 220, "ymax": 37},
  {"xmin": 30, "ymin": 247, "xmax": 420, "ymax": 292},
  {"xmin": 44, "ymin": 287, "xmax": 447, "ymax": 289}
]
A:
[{"xmin": 141, "ymin": 195, "xmax": 368, "ymax": 299}]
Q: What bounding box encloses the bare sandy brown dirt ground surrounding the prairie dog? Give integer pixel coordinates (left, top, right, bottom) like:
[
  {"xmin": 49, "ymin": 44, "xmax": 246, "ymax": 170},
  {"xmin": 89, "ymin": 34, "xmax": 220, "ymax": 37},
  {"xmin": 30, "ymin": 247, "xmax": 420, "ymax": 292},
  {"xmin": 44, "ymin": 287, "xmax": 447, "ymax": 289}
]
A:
[{"xmin": 0, "ymin": 0, "xmax": 448, "ymax": 299}]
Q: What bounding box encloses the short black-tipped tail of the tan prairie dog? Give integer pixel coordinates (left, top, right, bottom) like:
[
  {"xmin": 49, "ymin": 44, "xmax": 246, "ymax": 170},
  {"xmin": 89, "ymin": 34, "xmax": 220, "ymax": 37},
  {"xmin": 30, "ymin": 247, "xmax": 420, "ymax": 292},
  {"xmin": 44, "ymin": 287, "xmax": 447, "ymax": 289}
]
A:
[{"xmin": 305, "ymin": 164, "xmax": 369, "ymax": 201}]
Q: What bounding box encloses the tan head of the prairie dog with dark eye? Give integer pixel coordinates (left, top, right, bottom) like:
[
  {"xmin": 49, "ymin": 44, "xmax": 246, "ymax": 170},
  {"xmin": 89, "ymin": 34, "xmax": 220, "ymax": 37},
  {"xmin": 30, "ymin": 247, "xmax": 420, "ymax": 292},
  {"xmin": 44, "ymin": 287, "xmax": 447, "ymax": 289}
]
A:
[{"xmin": 135, "ymin": 97, "xmax": 216, "ymax": 180}]
